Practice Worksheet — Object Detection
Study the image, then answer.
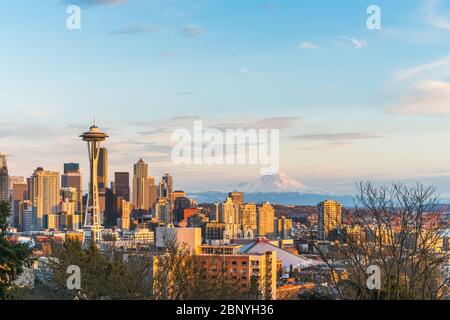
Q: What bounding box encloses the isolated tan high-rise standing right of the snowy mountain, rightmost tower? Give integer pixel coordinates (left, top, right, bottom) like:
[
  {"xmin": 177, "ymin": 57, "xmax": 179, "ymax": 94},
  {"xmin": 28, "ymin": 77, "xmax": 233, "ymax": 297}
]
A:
[{"xmin": 317, "ymin": 200, "xmax": 342, "ymax": 240}]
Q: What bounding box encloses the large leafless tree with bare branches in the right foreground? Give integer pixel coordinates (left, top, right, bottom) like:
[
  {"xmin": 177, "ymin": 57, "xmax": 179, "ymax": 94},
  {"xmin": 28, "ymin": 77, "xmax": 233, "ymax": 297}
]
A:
[{"xmin": 317, "ymin": 182, "xmax": 450, "ymax": 300}]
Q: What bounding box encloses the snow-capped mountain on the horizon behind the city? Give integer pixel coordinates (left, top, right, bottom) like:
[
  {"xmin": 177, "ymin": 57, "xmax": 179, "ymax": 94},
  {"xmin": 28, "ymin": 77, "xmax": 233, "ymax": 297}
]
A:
[{"xmin": 236, "ymin": 172, "xmax": 326, "ymax": 194}]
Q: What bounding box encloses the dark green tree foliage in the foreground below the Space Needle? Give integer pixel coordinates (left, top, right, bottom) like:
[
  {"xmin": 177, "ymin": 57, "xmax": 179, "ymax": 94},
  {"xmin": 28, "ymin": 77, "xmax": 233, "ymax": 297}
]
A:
[{"xmin": 32, "ymin": 240, "xmax": 151, "ymax": 300}]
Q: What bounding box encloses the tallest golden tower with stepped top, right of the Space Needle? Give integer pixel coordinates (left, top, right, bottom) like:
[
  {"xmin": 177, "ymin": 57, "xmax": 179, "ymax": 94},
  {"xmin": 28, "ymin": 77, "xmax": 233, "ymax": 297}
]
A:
[{"xmin": 133, "ymin": 159, "xmax": 157, "ymax": 211}]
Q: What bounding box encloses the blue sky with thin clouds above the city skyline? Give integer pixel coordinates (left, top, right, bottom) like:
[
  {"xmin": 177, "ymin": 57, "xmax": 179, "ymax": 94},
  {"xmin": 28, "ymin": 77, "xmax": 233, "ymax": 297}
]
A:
[{"xmin": 0, "ymin": 0, "xmax": 450, "ymax": 194}]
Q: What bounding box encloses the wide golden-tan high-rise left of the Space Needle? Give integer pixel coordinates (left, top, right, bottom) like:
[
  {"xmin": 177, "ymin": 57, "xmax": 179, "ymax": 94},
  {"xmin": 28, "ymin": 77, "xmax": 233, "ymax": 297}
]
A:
[{"xmin": 31, "ymin": 168, "xmax": 60, "ymax": 230}]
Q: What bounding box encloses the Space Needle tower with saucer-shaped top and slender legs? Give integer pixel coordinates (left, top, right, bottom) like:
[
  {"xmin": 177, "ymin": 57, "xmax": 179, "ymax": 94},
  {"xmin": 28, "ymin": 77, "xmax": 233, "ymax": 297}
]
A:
[{"xmin": 80, "ymin": 121, "xmax": 108, "ymax": 243}]
